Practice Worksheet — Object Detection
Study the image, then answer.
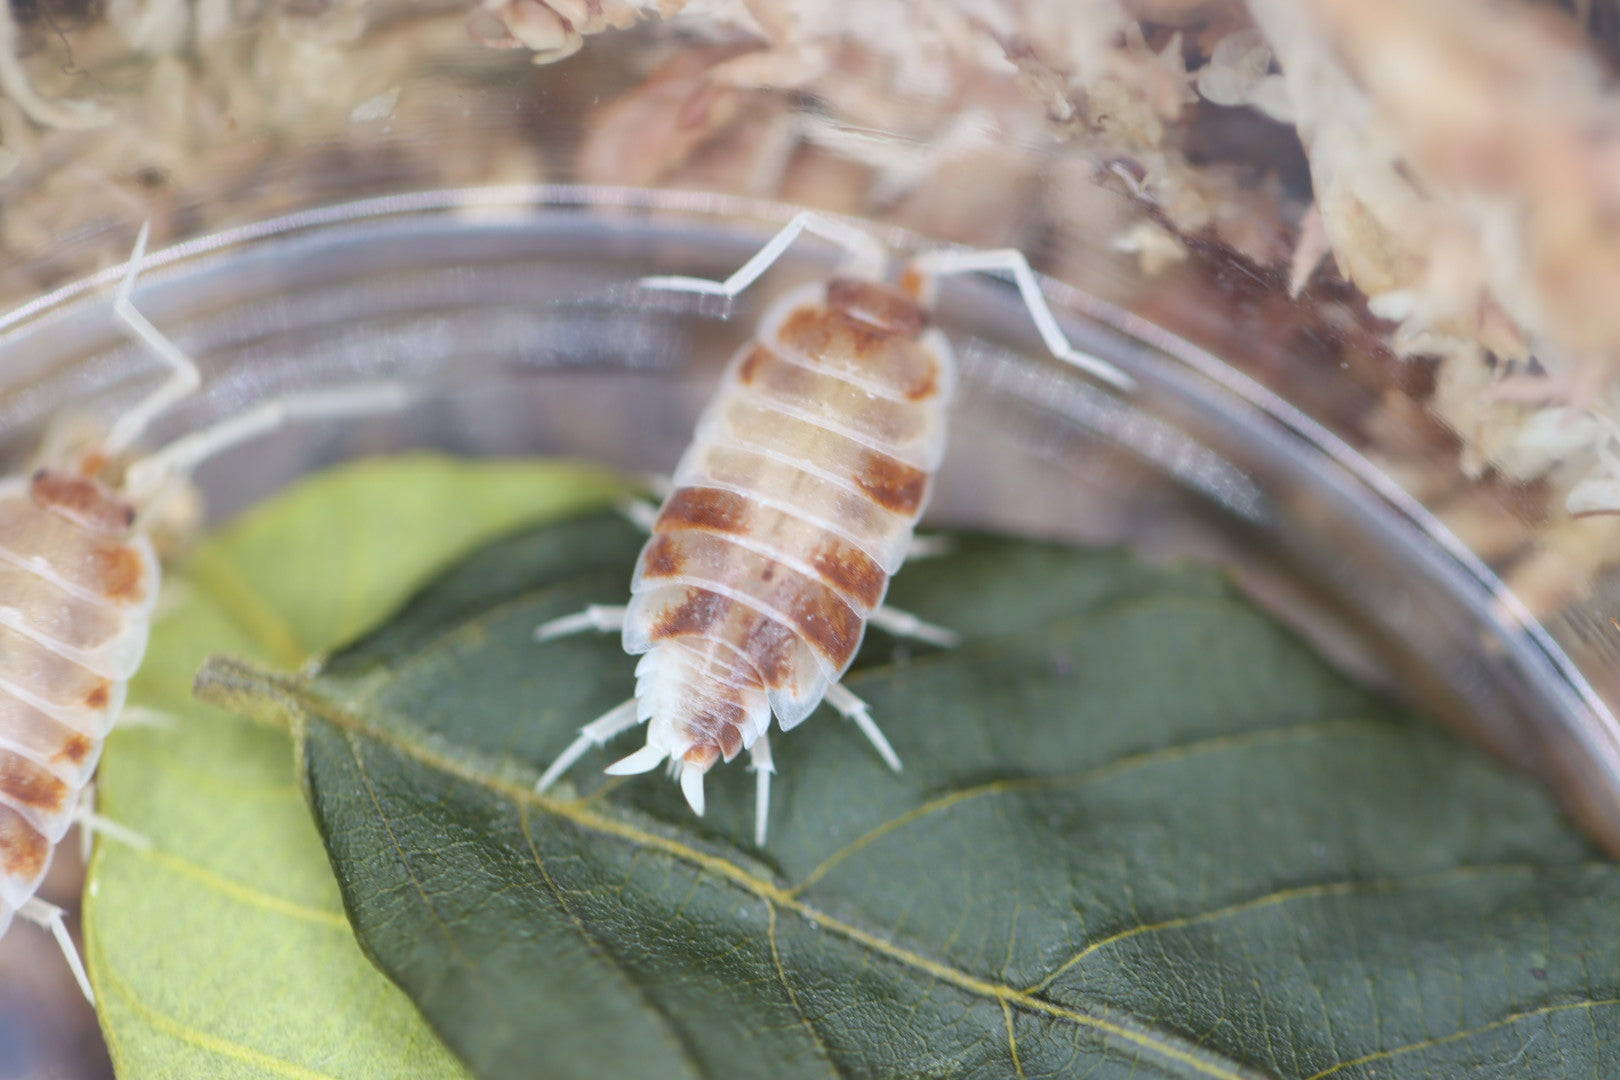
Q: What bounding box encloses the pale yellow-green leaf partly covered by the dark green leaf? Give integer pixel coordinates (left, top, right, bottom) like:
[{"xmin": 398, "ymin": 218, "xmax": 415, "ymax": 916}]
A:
[{"xmin": 84, "ymin": 457, "xmax": 617, "ymax": 1080}]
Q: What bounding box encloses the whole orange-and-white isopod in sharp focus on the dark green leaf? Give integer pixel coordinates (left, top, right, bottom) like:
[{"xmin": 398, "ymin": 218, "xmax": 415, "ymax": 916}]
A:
[{"xmin": 536, "ymin": 214, "xmax": 1134, "ymax": 844}]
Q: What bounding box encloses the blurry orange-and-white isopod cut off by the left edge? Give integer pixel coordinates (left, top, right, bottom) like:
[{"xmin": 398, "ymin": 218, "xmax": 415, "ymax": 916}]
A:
[{"xmin": 0, "ymin": 225, "xmax": 407, "ymax": 1001}]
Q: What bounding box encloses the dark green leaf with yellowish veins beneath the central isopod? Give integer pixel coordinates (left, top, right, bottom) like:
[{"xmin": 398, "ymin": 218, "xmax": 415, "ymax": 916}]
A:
[{"xmin": 192, "ymin": 505, "xmax": 1620, "ymax": 1080}]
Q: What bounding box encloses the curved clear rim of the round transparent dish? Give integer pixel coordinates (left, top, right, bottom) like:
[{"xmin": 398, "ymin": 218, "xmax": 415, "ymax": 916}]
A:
[{"xmin": 0, "ymin": 185, "xmax": 1620, "ymax": 841}]
